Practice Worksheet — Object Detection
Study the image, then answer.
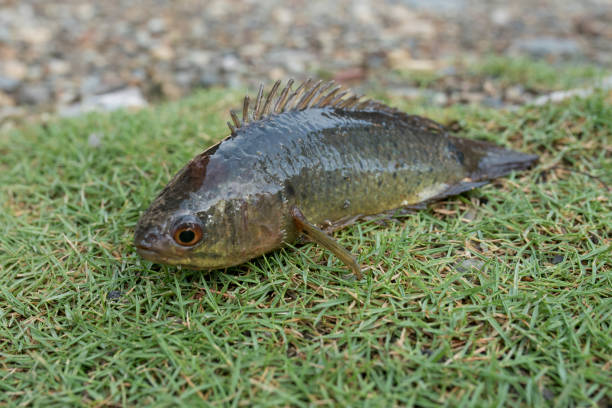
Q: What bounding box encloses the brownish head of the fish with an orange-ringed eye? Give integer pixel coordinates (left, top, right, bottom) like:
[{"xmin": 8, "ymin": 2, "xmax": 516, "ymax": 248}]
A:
[{"xmin": 134, "ymin": 152, "xmax": 283, "ymax": 270}]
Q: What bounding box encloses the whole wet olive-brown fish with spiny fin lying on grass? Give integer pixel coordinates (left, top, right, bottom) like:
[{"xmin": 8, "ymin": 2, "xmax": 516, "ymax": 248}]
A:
[{"xmin": 134, "ymin": 79, "xmax": 538, "ymax": 279}]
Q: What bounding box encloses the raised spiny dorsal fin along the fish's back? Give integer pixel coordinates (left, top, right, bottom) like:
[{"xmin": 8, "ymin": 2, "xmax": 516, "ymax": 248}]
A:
[{"xmin": 227, "ymin": 79, "xmax": 399, "ymax": 136}]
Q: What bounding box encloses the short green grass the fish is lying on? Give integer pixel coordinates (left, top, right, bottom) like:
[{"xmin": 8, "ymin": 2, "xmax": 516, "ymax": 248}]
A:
[{"xmin": 0, "ymin": 62, "xmax": 612, "ymax": 407}]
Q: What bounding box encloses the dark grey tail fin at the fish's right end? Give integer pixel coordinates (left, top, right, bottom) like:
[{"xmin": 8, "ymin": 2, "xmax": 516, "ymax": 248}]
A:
[{"xmin": 453, "ymin": 137, "xmax": 539, "ymax": 181}]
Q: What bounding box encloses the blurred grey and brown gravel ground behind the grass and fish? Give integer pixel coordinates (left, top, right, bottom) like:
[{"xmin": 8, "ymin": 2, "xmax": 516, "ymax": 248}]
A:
[{"xmin": 0, "ymin": 0, "xmax": 612, "ymax": 120}]
